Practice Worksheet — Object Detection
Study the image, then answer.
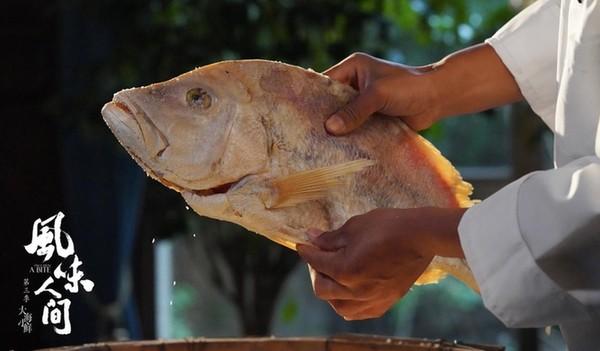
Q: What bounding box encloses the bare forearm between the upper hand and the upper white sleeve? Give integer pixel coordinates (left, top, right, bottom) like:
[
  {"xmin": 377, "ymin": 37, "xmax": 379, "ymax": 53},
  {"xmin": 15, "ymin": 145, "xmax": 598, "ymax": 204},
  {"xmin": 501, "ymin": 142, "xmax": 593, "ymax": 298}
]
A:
[{"xmin": 424, "ymin": 44, "xmax": 523, "ymax": 120}]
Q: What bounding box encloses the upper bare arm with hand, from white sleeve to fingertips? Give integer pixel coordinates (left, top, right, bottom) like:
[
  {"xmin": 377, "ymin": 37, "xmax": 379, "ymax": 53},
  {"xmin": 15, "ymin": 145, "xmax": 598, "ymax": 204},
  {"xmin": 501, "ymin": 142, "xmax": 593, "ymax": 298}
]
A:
[{"xmin": 325, "ymin": 44, "xmax": 523, "ymax": 135}]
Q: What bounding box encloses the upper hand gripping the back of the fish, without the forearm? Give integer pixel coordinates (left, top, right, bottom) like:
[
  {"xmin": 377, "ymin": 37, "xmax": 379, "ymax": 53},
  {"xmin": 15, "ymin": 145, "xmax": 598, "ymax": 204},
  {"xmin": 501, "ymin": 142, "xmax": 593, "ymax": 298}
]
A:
[{"xmin": 323, "ymin": 53, "xmax": 439, "ymax": 135}]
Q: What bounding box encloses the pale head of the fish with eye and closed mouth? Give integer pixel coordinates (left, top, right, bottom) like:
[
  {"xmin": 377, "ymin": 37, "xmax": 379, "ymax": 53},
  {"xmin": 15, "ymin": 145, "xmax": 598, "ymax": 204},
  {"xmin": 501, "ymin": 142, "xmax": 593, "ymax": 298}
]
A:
[{"xmin": 102, "ymin": 64, "xmax": 268, "ymax": 192}]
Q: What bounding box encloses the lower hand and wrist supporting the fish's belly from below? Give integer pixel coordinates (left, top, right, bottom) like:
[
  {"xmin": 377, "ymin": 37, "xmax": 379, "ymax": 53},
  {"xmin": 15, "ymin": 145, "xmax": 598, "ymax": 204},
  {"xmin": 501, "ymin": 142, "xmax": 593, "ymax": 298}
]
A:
[{"xmin": 297, "ymin": 208, "xmax": 465, "ymax": 320}]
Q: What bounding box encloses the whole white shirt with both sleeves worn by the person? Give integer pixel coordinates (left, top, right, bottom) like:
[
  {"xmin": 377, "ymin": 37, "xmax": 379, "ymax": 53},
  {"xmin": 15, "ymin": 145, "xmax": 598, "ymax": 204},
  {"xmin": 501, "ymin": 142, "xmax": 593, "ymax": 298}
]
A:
[{"xmin": 459, "ymin": 0, "xmax": 600, "ymax": 351}]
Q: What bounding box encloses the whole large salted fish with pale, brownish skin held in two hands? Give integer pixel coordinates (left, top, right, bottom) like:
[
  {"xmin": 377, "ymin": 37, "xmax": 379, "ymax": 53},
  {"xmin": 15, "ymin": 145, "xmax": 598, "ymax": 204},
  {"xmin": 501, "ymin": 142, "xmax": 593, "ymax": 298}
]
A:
[{"xmin": 102, "ymin": 60, "xmax": 477, "ymax": 289}]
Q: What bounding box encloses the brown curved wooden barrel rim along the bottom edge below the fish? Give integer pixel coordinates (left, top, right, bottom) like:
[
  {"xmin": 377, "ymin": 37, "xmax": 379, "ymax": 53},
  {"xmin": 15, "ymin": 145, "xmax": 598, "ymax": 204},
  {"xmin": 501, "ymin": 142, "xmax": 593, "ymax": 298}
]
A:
[{"xmin": 43, "ymin": 335, "xmax": 504, "ymax": 351}]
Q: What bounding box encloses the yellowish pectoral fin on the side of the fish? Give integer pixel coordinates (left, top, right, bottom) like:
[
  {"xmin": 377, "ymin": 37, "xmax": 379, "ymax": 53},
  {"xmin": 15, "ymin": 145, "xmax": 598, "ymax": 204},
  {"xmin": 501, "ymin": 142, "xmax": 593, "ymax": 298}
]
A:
[{"xmin": 261, "ymin": 159, "xmax": 375, "ymax": 208}]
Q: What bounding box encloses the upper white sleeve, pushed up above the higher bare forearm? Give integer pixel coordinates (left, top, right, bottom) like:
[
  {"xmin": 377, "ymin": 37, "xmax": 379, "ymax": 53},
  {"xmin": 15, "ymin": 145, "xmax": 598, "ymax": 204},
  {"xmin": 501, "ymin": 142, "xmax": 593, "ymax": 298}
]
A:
[{"xmin": 486, "ymin": 0, "xmax": 560, "ymax": 129}]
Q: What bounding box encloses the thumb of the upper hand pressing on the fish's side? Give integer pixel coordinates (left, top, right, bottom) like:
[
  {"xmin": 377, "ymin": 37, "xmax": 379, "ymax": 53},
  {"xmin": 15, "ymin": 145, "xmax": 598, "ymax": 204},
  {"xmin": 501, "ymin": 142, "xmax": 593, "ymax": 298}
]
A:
[{"xmin": 325, "ymin": 87, "xmax": 381, "ymax": 135}]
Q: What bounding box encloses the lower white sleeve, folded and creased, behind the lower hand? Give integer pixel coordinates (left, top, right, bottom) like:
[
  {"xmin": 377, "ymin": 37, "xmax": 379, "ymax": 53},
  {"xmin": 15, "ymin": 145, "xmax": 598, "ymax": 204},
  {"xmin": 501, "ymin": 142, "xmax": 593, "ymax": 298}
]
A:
[{"xmin": 459, "ymin": 156, "xmax": 600, "ymax": 327}]
